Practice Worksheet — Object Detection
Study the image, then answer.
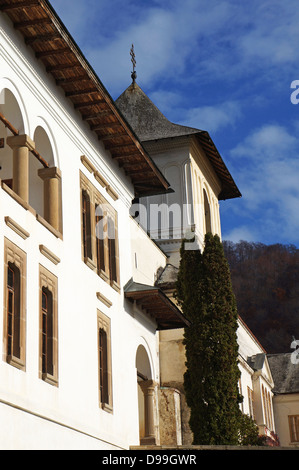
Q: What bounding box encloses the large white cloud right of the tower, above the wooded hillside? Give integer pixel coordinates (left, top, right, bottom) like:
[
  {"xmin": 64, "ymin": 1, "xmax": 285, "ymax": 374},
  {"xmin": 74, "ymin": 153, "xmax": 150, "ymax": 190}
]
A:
[{"xmin": 231, "ymin": 124, "xmax": 299, "ymax": 242}]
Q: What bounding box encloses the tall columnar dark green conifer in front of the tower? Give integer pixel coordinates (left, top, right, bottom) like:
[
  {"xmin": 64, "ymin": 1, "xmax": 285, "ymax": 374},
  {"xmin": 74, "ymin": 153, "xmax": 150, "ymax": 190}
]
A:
[{"xmin": 176, "ymin": 233, "xmax": 242, "ymax": 445}]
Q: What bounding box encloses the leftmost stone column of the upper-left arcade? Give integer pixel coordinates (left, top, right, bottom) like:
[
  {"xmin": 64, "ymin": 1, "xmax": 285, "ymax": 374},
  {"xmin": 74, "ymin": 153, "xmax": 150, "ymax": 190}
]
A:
[{"xmin": 6, "ymin": 135, "xmax": 35, "ymax": 203}]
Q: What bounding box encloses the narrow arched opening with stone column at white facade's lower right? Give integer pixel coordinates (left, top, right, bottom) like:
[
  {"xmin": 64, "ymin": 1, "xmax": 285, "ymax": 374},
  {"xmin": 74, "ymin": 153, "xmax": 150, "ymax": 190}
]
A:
[{"xmin": 136, "ymin": 345, "xmax": 156, "ymax": 444}]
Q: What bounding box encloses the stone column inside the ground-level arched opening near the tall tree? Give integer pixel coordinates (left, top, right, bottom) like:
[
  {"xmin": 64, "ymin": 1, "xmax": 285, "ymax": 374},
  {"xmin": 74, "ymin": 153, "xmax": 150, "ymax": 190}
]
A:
[{"xmin": 139, "ymin": 380, "xmax": 156, "ymax": 445}]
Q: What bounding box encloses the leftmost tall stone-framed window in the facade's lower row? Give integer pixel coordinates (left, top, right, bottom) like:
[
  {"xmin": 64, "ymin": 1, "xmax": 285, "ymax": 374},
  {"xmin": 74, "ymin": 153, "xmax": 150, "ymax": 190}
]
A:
[{"xmin": 3, "ymin": 238, "xmax": 27, "ymax": 371}]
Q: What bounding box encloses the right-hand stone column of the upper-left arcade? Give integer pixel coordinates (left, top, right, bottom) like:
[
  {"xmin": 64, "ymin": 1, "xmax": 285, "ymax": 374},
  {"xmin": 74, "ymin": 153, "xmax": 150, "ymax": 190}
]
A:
[{"xmin": 38, "ymin": 167, "xmax": 61, "ymax": 232}]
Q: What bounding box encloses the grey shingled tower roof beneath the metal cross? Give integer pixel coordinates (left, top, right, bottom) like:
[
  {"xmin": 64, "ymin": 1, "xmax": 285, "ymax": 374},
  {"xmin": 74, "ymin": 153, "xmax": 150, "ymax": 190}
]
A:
[{"xmin": 116, "ymin": 81, "xmax": 241, "ymax": 199}]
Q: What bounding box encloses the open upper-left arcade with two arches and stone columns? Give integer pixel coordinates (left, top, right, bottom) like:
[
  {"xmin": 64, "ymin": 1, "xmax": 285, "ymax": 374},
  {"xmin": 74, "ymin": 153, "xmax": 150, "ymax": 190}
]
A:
[{"xmin": 0, "ymin": 88, "xmax": 62, "ymax": 232}]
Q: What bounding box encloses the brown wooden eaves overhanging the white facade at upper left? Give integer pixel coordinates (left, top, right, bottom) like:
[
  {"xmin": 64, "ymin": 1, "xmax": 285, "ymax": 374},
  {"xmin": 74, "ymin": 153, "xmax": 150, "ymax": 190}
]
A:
[{"xmin": 0, "ymin": 0, "xmax": 169, "ymax": 197}]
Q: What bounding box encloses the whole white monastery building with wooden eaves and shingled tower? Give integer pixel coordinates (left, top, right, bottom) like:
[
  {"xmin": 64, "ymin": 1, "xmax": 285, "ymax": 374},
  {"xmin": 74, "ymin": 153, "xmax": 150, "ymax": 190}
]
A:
[{"xmin": 0, "ymin": 0, "xmax": 299, "ymax": 450}]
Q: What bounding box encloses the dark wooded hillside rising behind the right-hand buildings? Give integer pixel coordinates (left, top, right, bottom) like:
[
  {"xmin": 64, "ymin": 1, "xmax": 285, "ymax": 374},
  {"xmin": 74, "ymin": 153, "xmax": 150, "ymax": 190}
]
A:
[{"xmin": 223, "ymin": 241, "xmax": 299, "ymax": 353}]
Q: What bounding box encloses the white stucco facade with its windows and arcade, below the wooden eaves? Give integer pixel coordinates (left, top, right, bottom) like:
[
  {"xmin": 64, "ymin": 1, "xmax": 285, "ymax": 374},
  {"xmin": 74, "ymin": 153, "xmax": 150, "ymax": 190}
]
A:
[{"xmin": 0, "ymin": 1, "xmax": 189, "ymax": 450}]
